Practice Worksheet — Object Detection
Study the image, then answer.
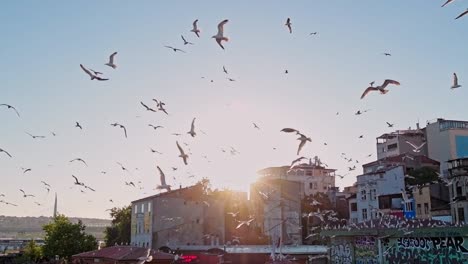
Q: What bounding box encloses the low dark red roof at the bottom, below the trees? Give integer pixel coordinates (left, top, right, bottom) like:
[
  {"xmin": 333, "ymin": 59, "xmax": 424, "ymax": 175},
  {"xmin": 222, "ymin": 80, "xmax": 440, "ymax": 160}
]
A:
[{"xmin": 72, "ymin": 246, "xmax": 174, "ymax": 264}]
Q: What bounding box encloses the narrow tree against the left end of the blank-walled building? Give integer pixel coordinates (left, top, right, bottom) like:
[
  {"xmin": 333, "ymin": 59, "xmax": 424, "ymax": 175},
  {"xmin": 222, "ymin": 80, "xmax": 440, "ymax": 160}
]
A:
[{"xmin": 104, "ymin": 205, "xmax": 132, "ymax": 246}]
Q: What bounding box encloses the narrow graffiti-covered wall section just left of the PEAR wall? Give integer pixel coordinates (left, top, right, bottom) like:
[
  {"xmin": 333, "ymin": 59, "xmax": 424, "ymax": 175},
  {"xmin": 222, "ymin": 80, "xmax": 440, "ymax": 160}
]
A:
[{"xmin": 354, "ymin": 236, "xmax": 379, "ymax": 264}]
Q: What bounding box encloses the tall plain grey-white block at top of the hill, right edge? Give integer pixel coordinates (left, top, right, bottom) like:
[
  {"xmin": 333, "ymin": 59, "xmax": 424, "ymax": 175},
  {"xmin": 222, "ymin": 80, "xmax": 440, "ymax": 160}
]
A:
[{"xmin": 424, "ymin": 118, "xmax": 468, "ymax": 176}]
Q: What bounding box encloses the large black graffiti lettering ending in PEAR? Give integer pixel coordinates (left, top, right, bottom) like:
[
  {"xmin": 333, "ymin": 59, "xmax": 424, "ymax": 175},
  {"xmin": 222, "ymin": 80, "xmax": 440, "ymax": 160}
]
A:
[{"xmin": 397, "ymin": 237, "xmax": 468, "ymax": 253}]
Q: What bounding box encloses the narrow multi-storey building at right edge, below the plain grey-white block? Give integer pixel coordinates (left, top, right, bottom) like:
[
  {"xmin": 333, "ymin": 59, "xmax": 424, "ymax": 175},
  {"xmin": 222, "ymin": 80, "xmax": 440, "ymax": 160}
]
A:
[{"xmin": 448, "ymin": 158, "xmax": 468, "ymax": 223}]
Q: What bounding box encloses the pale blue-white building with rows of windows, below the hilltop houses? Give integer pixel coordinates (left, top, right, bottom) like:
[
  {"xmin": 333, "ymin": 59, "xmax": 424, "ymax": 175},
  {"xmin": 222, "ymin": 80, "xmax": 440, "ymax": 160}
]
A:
[{"xmin": 354, "ymin": 165, "xmax": 413, "ymax": 223}]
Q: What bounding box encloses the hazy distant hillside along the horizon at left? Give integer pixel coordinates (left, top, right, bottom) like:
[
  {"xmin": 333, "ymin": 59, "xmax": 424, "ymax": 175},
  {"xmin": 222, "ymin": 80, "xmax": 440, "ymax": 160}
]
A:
[{"xmin": 0, "ymin": 215, "xmax": 111, "ymax": 240}]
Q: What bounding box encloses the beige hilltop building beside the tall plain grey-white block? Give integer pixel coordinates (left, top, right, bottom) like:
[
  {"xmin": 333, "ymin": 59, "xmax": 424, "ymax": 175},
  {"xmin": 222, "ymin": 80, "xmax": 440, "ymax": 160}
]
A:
[{"xmin": 377, "ymin": 127, "xmax": 427, "ymax": 160}]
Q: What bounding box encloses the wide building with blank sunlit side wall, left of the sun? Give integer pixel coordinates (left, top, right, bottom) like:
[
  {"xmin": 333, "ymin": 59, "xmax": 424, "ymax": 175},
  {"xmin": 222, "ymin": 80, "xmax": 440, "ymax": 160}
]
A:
[{"xmin": 131, "ymin": 183, "xmax": 247, "ymax": 249}]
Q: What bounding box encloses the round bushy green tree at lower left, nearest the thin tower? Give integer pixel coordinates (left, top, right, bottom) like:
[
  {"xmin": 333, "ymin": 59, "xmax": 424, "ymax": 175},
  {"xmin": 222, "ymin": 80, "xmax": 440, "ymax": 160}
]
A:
[{"xmin": 42, "ymin": 215, "xmax": 97, "ymax": 259}]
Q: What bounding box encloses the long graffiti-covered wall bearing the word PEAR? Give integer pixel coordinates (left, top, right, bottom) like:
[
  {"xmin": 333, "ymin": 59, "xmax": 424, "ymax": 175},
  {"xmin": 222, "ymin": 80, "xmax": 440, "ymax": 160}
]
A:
[{"xmin": 382, "ymin": 236, "xmax": 468, "ymax": 264}]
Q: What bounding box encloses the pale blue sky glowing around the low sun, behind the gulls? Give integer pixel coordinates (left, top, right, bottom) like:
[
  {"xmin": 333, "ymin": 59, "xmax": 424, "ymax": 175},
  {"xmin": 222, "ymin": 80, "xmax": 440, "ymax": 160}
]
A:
[{"xmin": 0, "ymin": 0, "xmax": 468, "ymax": 218}]
